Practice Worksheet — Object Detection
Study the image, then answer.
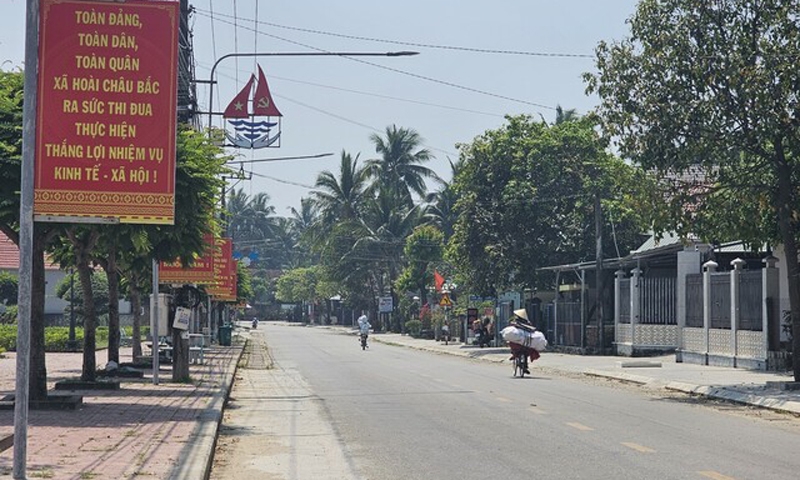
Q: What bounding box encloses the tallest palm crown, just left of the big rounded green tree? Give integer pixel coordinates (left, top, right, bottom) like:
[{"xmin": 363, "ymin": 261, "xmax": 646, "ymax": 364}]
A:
[{"xmin": 366, "ymin": 125, "xmax": 441, "ymax": 204}]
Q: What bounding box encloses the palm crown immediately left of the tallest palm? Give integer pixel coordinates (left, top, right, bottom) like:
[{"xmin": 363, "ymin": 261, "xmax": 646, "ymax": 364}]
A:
[{"xmin": 311, "ymin": 150, "xmax": 367, "ymax": 230}]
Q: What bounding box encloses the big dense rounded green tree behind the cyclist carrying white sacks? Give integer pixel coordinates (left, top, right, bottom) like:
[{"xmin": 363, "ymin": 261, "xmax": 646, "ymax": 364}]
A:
[{"xmin": 446, "ymin": 115, "xmax": 643, "ymax": 294}]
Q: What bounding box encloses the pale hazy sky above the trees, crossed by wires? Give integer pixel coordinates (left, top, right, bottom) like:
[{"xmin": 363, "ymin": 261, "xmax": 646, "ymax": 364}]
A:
[{"xmin": 0, "ymin": 0, "xmax": 636, "ymax": 215}]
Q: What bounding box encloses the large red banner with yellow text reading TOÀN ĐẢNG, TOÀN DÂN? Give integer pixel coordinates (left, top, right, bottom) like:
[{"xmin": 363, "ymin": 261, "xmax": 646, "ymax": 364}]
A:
[{"xmin": 33, "ymin": 0, "xmax": 179, "ymax": 224}]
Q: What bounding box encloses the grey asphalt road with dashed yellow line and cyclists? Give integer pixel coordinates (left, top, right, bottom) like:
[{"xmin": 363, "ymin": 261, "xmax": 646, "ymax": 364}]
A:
[{"xmin": 212, "ymin": 322, "xmax": 800, "ymax": 480}]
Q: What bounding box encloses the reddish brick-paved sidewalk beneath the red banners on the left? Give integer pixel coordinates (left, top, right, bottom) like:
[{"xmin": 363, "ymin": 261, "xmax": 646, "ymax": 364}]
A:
[{"xmin": 0, "ymin": 329, "xmax": 246, "ymax": 480}]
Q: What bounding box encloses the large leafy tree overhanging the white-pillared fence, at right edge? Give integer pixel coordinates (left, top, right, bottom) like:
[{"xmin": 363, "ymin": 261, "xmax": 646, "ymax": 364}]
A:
[{"xmin": 585, "ymin": 0, "xmax": 800, "ymax": 381}]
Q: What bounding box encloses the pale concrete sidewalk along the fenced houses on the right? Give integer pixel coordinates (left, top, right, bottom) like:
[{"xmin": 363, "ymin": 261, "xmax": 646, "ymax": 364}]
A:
[{"xmin": 354, "ymin": 328, "xmax": 800, "ymax": 415}]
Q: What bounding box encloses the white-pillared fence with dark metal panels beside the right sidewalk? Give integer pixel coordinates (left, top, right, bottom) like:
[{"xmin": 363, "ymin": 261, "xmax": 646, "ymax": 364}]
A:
[{"xmin": 614, "ymin": 258, "xmax": 778, "ymax": 369}]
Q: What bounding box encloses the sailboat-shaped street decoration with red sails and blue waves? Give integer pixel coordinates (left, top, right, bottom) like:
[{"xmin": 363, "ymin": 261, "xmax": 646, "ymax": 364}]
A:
[{"xmin": 222, "ymin": 65, "xmax": 283, "ymax": 149}]
